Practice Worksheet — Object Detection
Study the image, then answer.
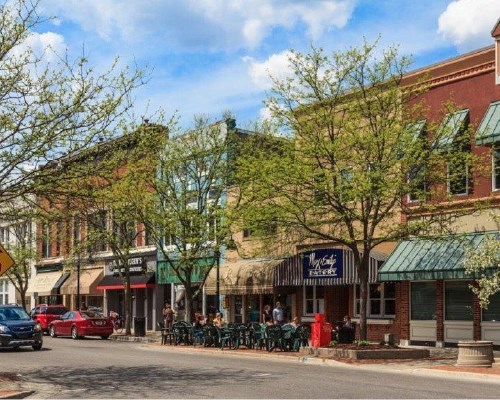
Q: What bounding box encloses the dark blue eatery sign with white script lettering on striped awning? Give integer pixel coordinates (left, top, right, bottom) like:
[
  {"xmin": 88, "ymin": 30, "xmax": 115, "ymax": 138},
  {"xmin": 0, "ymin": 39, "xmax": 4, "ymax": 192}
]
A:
[{"xmin": 302, "ymin": 249, "xmax": 344, "ymax": 279}]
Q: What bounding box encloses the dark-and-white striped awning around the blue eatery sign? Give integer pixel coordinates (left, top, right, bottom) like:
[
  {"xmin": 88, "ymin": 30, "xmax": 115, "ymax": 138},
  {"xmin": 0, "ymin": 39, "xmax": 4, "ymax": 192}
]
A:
[{"xmin": 274, "ymin": 250, "xmax": 384, "ymax": 286}]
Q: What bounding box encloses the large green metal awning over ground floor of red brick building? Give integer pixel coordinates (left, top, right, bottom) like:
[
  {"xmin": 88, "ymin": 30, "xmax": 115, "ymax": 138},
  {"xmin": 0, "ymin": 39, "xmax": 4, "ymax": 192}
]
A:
[{"xmin": 378, "ymin": 231, "xmax": 500, "ymax": 281}]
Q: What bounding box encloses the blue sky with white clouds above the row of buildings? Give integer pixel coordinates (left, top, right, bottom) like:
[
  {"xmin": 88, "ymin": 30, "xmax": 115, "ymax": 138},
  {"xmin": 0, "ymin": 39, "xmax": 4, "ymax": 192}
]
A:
[{"xmin": 30, "ymin": 0, "xmax": 500, "ymax": 127}]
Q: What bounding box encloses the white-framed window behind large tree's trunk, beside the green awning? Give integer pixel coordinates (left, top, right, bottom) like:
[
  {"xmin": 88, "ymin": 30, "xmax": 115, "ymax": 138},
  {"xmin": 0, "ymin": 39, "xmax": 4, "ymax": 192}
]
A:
[{"xmin": 355, "ymin": 282, "xmax": 396, "ymax": 318}]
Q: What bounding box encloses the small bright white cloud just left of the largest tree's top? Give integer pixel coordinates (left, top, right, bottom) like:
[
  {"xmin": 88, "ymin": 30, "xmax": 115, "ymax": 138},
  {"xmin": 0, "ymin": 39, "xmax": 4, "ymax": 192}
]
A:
[{"xmin": 243, "ymin": 51, "xmax": 292, "ymax": 90}]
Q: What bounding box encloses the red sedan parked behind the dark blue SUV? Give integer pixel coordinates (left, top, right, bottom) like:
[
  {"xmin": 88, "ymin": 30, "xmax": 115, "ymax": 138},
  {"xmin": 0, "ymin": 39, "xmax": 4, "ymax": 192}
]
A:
[{"xmin": 49, "ymin": 310, "xmax": 113, "ymax": 339}]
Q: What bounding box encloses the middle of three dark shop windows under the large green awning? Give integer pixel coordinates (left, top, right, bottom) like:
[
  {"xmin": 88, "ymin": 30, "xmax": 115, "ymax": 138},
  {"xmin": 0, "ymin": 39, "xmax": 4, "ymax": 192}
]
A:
[{"xmin": 444, "ymin": 282, "xmax": 472, "ymax": 321}]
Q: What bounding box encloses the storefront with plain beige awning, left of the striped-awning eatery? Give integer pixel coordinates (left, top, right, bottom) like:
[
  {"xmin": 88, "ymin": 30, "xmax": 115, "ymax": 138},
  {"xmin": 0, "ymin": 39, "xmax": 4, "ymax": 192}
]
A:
[{"xmin": 205, "ymin": 259, "xmax": 286, "ymax": 323}]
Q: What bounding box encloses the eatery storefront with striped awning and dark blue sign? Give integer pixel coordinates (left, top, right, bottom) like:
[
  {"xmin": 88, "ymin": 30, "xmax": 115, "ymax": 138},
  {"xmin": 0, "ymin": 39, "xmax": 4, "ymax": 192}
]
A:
[{"xmin": 275, "ymin": 248, "xmax": 395, "ymax": 340}]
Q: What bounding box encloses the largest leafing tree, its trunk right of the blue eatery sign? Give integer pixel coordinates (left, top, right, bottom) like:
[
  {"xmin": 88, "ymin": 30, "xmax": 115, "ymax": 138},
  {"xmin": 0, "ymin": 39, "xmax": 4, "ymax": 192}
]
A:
[{"xmin": 232, "ymin": 43, "xmax": 472, "ymax": 339}]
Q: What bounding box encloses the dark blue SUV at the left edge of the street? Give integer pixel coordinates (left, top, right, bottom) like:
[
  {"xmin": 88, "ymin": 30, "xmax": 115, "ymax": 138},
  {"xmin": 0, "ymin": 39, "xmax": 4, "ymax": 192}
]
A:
[{"xmin": 0, "ymin": 305, "xmax": 43, "ymax": 350}]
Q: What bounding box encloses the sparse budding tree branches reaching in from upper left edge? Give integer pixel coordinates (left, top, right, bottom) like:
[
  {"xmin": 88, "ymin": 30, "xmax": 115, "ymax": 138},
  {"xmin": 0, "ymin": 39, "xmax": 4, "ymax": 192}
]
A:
[{"xmin": 0, "ymin": 0, "xmax": 147, "ymax": 211}]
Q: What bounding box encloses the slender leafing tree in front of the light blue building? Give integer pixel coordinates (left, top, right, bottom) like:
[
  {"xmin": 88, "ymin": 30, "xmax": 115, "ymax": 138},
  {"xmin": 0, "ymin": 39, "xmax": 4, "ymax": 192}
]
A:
[{"xmin": 138, "ymin": 116, "xmax": 237, "ymax": 320}]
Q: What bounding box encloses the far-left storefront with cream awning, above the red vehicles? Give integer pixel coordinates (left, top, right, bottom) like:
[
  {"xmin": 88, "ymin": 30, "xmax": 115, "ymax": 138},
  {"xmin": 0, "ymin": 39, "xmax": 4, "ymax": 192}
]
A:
[{"xmin": 26, "ymin": 264, "xmax": 69, "ymax": 306}]
